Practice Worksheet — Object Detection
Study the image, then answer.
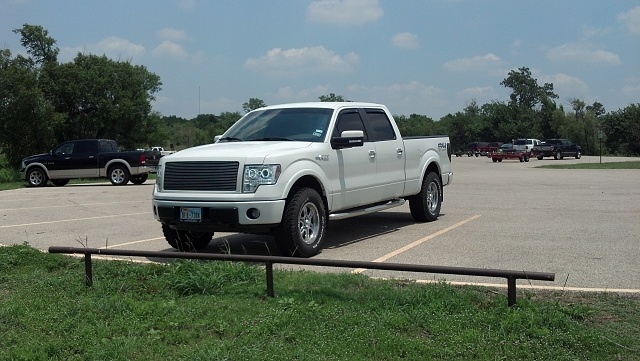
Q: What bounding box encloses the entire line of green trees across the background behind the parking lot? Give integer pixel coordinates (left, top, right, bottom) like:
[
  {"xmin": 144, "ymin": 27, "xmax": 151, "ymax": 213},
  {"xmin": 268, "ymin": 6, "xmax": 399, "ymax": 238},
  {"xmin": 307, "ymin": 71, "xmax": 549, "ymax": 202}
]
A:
[{"xmin": 0, "ymin": 24, "xmax": 640, "ymax": 167}]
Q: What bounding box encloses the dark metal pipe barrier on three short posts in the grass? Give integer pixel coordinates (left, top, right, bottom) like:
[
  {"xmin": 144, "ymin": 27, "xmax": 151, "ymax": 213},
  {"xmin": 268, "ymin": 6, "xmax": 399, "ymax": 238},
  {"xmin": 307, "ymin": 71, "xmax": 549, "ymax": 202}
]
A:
[{"xmin": 49, "ymin": 246, "xmax": 555, "ymax": 306}]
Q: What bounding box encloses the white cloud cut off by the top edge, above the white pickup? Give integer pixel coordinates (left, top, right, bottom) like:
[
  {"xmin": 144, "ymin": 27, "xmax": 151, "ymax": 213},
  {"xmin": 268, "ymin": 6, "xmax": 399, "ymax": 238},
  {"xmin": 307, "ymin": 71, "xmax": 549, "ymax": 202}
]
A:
[{"xmin": 307, "ymin": 0, "xmax": 384, "ymax": 25}]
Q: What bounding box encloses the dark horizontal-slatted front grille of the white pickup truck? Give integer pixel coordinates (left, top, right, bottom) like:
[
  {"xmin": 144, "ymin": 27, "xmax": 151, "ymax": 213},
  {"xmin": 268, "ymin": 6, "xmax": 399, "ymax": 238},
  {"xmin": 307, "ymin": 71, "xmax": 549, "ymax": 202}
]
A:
[{"xmin": 164, "ymin": 161, "xmax": 238, "ymax": 192}]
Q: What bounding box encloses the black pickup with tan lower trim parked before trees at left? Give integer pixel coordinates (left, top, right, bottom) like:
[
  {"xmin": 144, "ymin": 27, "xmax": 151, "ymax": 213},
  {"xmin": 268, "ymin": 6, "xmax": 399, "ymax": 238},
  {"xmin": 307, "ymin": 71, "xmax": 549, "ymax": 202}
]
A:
[{"xmin": 20, "ymin": 139, "xmax": 149, "ymax": 187}]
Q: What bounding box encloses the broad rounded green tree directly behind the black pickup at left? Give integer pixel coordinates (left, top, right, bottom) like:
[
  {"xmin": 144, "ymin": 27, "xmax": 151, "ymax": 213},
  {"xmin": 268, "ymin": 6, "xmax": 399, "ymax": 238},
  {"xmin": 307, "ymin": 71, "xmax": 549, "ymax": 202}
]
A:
[{"xmin": 49, "ymin": 54, "xmax": 162, "ymax": 148}]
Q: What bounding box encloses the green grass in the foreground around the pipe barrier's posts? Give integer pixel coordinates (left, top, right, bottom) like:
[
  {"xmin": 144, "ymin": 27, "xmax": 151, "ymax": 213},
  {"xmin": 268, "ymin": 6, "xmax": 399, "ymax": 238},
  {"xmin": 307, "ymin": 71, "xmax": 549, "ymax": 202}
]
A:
[{"xmin": 0, "ymin": 245, "xmax": 640, "ymax": 361}]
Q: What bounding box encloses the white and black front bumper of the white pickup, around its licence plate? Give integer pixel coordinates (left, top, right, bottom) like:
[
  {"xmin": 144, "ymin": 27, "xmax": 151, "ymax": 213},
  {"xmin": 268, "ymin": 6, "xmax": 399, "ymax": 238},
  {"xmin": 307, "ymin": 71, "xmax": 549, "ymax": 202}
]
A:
[{"xmin": 152, "ymin": 199, "xmax": 285, "ymax": 232}]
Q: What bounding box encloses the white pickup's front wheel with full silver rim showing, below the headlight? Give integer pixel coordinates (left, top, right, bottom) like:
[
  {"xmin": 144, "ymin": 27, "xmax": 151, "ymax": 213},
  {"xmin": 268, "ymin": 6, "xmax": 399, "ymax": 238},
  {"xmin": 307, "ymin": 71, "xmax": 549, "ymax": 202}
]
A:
[{"xmin": 274, "ymin": 188, "xmax": 327, "ymax": 257}]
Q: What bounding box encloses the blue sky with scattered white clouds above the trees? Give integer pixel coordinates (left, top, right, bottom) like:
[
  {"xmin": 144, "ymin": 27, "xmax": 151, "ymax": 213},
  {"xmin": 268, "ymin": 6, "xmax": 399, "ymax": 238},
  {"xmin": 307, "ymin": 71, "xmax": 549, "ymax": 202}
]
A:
[{"xmin": 0, "ymin": 0, "xmax": 640, "ymax": 120}]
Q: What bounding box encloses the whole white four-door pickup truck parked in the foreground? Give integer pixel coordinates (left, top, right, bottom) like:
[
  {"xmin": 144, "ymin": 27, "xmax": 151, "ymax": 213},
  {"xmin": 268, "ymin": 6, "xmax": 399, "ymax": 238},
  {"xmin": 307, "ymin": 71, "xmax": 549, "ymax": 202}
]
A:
[{"xmin": 153, "ymin": 102, "xmax": 453, "ymax": 257}]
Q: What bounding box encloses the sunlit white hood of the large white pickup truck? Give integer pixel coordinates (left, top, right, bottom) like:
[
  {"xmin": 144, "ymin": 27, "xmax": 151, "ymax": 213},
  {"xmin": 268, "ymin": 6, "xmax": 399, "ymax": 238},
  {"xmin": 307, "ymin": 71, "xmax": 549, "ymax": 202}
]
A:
[{"xmin": 161, "ymin": 141, "xmax": 312, "ymax": 162}]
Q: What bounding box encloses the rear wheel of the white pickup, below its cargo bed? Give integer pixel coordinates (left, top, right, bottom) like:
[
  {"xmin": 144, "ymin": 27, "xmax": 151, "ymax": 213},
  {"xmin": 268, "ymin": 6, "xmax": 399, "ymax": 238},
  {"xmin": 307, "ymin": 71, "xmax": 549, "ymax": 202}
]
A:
[{"xmin": 409, "ymin": 172, "xmax": 442, "ymax": 222}]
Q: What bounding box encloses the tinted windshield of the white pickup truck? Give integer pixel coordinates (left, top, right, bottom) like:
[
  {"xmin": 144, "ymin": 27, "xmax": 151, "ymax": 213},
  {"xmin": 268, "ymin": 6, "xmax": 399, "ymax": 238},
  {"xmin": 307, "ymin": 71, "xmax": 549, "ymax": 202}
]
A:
[{"xmin": 219, "ymin": 108, "xmax": 333, "ymax": 142}]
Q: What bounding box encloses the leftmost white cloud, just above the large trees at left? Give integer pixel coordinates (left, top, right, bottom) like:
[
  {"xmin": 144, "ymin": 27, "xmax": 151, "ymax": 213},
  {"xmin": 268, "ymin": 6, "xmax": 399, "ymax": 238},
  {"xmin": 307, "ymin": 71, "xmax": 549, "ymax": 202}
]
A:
[{"xmin": 60, "ymin": 36, "xmax": 146, "ymax": 61}]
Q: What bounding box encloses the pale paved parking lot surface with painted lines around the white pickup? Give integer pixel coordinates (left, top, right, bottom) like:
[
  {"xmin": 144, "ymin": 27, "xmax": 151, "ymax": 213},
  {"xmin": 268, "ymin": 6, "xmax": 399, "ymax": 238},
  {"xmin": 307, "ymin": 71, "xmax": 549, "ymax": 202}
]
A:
[{"xmin": 0, "ymin": 156, "xmax": 640, "ymax": 293}]
